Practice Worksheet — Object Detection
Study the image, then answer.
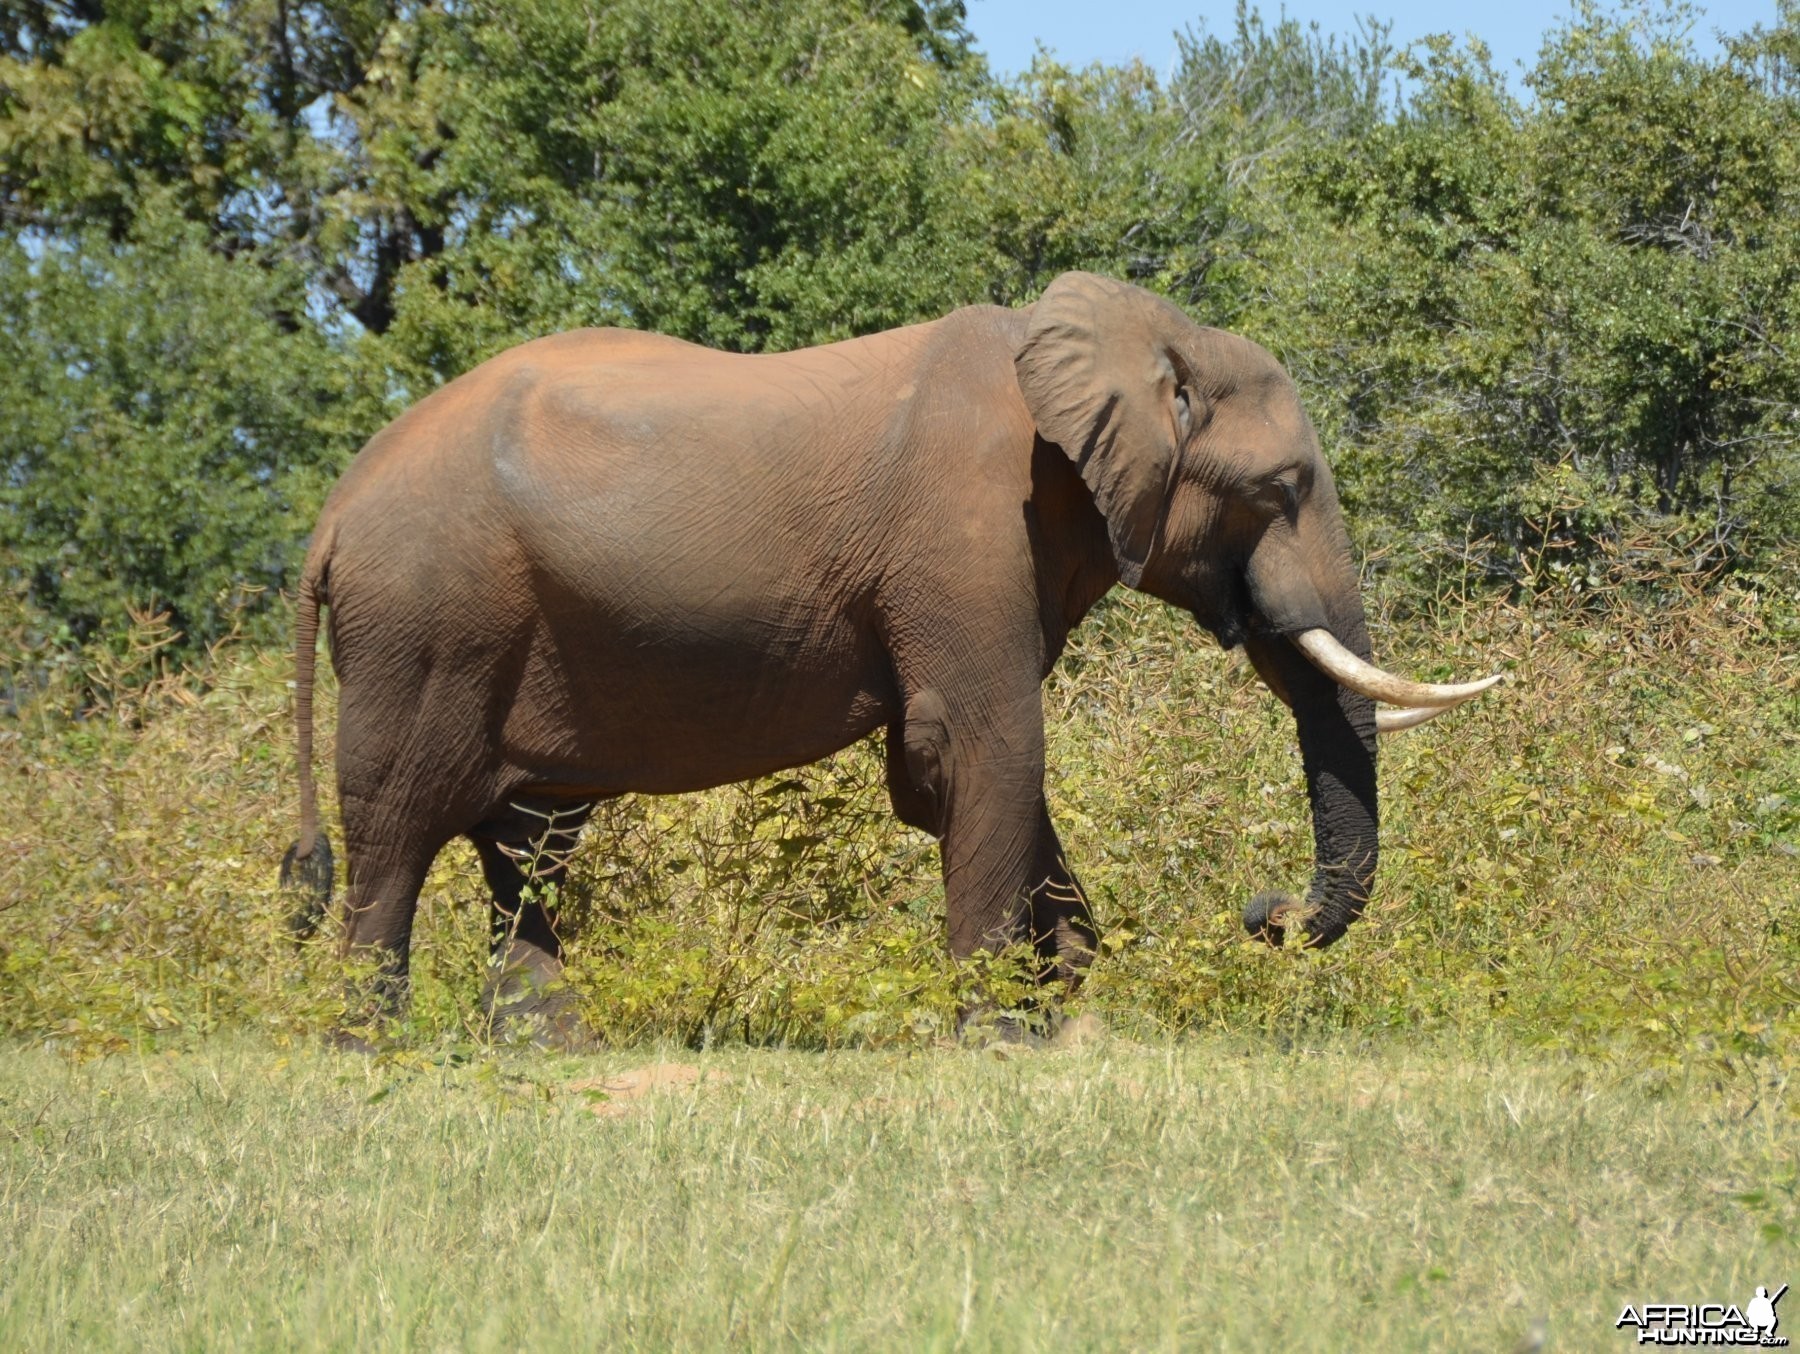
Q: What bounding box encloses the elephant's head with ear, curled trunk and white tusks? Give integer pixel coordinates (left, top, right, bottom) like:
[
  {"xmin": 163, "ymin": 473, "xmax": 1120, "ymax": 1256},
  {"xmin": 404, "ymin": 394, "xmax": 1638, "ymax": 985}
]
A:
[{"xmin": 1015, "ymin": 272, "xmax": 1499, "ymax": 945}]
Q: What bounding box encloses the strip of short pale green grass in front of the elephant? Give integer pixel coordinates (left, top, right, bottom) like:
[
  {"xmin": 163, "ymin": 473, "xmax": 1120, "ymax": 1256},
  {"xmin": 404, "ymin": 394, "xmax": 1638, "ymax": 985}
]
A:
[{"xmin": 0, "ymin": 1037, "xmax": 1800, "ymax": 1350}]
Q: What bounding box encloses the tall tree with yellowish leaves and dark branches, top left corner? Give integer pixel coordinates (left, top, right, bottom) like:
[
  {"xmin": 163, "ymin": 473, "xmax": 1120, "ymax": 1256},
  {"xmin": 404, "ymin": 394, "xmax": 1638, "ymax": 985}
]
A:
[{"xmin": 0, "ymin": 0, "xmax": 450, "ymax": 331}]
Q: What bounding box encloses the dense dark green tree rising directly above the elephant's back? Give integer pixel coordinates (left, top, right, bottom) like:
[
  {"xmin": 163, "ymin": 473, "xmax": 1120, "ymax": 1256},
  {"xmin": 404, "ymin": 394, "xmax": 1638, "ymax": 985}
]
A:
[{"xmin": 379, "ymin": 0, "xmax": 981, "ymax": 375}]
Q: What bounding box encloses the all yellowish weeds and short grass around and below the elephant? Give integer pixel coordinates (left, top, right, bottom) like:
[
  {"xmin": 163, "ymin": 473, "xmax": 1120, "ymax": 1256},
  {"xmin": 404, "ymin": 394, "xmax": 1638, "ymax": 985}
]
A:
[{"xmin": 0, "ymin": 568, "xmax": 1800, "ymax": 1349}]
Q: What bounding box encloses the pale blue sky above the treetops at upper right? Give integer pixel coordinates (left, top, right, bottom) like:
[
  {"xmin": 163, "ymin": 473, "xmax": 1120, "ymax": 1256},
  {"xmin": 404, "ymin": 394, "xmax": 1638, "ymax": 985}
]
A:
[{"xmin": 967, "ymin": 0, "xmax": 1777, "ymax": 88}]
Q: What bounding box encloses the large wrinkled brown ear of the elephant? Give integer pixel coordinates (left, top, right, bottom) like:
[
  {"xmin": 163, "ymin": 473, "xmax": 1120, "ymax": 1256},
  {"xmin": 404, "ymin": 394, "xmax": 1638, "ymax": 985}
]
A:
[{"xmin": 1013, "ymin": 272, "xmax": 1201, "ymax": 587}]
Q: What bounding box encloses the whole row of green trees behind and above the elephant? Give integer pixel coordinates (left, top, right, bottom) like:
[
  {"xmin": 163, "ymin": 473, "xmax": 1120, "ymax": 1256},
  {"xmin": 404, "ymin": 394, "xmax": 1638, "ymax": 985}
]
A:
[{"xmin": 0, "ymin": 0, "xmax": 1800, "ymax": 643}]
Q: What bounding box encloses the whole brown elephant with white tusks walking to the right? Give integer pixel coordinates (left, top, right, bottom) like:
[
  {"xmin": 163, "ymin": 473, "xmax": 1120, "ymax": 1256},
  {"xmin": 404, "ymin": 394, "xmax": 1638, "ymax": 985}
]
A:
[{"xmin": 283, "ymin": 272, "xmax": 1499, "ymax": 1019}]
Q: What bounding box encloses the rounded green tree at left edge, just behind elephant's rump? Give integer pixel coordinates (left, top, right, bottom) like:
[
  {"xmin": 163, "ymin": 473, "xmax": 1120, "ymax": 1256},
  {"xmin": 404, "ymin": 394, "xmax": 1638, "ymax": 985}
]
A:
[{"xmin": 0, "ymin": 218, "xmax": 374, "ymax": 641}]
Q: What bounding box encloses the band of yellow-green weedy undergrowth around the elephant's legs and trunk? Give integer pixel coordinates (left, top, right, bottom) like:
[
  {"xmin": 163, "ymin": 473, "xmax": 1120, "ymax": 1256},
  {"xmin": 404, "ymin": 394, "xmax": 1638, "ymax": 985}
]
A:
[{"xmin": 0, "ymin": 567, "xmax": 1800, "ymax": 1094}]
